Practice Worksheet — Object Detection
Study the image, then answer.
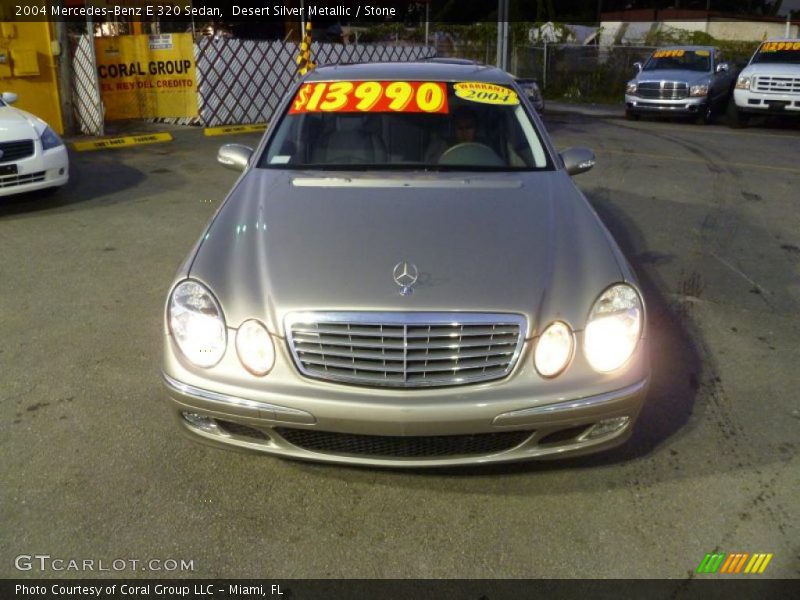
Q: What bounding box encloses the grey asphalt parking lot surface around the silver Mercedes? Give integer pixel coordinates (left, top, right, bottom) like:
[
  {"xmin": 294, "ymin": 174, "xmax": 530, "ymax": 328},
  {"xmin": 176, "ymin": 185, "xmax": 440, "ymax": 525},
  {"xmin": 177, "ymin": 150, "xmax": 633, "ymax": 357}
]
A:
[{"xmin": 0, "ymin": 114, "xmax": 800, "ymax": 578}]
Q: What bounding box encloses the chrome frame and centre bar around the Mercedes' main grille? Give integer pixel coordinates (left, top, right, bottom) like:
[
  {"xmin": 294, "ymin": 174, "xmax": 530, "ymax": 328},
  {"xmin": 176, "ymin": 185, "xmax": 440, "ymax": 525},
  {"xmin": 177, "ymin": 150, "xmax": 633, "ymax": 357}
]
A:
[{"xmin": 284, "ymin": 311, "xmax": 527, "ymax": 389}]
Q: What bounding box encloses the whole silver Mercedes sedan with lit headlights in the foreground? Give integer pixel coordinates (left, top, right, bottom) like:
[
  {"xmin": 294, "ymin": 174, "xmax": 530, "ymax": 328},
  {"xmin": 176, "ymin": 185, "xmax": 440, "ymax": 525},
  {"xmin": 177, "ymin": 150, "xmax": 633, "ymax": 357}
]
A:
[{"xmin": 163, "ymin": 61, "xmax": 649, "ymax": 466}]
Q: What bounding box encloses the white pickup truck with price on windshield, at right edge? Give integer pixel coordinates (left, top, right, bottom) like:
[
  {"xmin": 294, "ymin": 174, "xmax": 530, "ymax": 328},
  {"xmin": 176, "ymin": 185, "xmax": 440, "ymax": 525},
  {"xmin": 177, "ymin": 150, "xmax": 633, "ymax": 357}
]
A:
[{"xmin": 727, "ymin": 39, "xmax": 800, "ymax": 127}]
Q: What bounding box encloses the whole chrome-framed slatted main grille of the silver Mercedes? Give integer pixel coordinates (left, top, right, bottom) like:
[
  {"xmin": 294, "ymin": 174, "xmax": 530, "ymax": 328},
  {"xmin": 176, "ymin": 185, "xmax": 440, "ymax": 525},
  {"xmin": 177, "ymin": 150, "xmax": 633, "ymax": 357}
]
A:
[{"xmin": 286, "ymin": 313, "xmax": 525, "ymax": 388}]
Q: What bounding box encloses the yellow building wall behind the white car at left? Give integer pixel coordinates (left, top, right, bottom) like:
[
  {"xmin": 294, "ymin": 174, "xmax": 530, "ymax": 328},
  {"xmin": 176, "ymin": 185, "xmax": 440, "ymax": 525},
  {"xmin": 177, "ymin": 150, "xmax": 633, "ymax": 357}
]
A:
[{"xmin": 0, "ymin": 21, "xmax": 64, "ymax": 133}]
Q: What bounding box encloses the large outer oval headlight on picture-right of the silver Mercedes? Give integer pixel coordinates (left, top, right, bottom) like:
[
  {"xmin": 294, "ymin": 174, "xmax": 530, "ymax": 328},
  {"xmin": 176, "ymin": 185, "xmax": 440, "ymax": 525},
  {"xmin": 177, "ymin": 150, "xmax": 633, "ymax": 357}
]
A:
[{"xmin": 583, "ymin": 283, "xmax": 643, "ymax": 373}]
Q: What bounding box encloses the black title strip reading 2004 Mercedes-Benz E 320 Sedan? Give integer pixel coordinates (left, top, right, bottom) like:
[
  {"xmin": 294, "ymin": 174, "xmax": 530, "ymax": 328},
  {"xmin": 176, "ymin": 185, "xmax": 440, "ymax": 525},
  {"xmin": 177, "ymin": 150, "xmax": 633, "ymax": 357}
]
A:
[{"xmin": 0, "ymin": 0, "xmax": 788, "ymax": 27}]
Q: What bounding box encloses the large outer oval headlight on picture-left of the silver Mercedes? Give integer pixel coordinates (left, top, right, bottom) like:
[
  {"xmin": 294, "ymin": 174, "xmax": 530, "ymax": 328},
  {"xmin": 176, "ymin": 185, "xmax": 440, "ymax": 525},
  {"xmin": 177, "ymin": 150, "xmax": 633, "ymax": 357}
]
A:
[{"xmin": 169, "ymin": 281, "xmax": 227, "ymax": 367}]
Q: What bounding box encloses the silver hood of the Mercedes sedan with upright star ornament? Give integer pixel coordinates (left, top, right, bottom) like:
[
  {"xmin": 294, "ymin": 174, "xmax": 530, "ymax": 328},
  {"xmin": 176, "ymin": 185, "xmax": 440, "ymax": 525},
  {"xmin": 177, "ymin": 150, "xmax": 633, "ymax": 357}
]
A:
[{"xmin": 189, "ymin": 169, "xmax": 624, "ymax": 335}]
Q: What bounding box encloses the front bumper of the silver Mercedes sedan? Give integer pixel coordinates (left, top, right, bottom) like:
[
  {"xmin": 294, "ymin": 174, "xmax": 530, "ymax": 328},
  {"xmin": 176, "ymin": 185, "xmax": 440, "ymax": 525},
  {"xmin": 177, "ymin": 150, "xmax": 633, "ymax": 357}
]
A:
[{"xmin": 163, "ymin": 330, "xmax": 649, "ymax": 467}]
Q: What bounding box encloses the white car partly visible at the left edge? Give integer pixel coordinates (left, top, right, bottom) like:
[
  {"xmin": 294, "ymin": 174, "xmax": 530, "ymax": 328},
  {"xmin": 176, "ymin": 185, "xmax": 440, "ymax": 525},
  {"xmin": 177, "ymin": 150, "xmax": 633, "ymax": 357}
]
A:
[{"xmin": 0, "ymin": 92, "xmax": 69, "ymax": 197}]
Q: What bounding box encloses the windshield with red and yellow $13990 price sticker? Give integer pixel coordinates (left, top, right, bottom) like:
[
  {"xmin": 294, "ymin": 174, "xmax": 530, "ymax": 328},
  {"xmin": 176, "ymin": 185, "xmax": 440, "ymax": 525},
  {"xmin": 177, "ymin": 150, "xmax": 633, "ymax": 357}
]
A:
[{"xmin": 258, "ymin": 81, "xmax": 552, "ymax": 171}]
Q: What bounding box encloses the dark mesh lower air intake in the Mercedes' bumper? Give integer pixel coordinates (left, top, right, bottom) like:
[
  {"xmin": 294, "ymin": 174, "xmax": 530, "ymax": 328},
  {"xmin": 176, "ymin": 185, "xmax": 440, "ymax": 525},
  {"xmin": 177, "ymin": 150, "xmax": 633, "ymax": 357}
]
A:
[{"xmin": 275, "ymin": 427, "xmax": 533, "ymax": 458}]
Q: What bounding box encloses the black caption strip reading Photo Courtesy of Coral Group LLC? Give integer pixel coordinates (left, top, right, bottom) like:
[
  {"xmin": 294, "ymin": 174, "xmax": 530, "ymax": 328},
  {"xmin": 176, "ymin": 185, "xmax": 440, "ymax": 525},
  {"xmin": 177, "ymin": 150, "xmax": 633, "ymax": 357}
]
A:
[{"xmin": 0, "ymin": 575, "xmax": 800, "ymax": 600}]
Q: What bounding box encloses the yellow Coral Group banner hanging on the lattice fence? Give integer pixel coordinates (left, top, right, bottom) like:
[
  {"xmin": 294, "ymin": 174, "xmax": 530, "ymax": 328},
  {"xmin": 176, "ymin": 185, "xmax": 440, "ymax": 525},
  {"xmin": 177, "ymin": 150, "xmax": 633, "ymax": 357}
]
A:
[{"xmin": 95, "ymin": 33, "xmax": 197, "ymax": 120}]
